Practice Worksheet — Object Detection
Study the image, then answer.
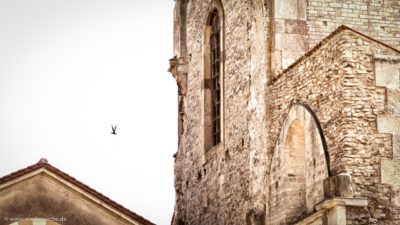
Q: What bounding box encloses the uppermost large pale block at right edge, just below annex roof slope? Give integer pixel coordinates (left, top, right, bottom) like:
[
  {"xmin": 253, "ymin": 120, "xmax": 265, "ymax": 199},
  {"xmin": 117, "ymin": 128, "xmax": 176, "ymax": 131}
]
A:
[{"xmin": 375, "ymin": 61, "xmax": 400, "ymax": 89}]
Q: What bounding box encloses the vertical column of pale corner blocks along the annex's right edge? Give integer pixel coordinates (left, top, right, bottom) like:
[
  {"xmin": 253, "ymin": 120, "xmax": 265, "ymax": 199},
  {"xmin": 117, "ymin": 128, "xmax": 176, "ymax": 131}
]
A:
[{"xmin": 374, "ymin": 55, "xmax": 400, "ymax": 224}]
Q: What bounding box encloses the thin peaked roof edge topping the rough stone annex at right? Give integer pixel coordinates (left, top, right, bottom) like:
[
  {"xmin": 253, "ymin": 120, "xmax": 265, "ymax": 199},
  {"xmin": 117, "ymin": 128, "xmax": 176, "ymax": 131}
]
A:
[{"xmin": 271, "ymin": 25, "xmax": 400, "ymax": 84}]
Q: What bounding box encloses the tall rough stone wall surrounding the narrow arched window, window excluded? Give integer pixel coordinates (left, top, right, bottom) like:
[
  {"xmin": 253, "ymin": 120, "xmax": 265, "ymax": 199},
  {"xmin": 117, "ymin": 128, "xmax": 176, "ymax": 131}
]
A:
[{"xmin": 175, "ymin": 0, "xmax": 269, "ymax": 224}]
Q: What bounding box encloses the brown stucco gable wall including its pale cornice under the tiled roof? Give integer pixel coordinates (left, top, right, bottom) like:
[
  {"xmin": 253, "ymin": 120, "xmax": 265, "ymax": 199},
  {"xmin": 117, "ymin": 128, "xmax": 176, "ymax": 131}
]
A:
[{"xmin": 0, "ymin": 169, "xmax": 151, "ymax": 225}]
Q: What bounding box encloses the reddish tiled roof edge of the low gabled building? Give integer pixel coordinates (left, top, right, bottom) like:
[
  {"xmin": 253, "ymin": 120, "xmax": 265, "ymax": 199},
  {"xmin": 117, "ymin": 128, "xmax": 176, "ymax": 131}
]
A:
[{"xmin": 0, "ymin": 159, "xmax": 155, "ymax": 225}]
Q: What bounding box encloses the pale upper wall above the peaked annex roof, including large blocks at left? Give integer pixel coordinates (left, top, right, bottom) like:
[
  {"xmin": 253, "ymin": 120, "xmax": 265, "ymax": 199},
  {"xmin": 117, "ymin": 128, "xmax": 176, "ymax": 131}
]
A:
[{"xmin": 271, "ymin": 0, "xmax": 400, "ymax": 74}]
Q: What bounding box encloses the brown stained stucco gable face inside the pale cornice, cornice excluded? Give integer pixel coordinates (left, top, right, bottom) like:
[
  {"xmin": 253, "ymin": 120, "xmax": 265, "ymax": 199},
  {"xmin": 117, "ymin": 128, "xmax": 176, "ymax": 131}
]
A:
[{"xmin": 0, "ymin": 176, "xmax": 119, "ymax": 225}]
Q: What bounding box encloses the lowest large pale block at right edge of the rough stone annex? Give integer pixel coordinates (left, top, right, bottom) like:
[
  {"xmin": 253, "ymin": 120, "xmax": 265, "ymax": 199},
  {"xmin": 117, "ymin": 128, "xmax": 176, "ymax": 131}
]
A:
[{"xmin": 381, "ymin": 159, "xmax": 400, "ymax": 186}]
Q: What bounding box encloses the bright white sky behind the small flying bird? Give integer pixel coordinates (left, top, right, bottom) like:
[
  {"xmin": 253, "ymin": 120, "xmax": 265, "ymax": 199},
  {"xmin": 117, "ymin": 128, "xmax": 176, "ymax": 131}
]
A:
[{"xmin": 0, "ymin": 0, "xmax": 177, "ymax": 225}]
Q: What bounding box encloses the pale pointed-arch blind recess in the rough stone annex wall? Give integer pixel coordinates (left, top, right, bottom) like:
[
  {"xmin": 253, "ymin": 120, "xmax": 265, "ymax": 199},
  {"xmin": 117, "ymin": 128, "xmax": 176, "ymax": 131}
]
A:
[{"xmin": 268, "ymin": 104, "xmax": 329, "ymax": 224}]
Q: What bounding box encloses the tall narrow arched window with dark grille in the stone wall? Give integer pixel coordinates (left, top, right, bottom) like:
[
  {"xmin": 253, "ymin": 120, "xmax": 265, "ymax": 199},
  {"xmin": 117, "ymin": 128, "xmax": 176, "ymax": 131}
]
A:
[{"xmin": 204, "ymin": 4, "xmax": 223, "ymax": 150}]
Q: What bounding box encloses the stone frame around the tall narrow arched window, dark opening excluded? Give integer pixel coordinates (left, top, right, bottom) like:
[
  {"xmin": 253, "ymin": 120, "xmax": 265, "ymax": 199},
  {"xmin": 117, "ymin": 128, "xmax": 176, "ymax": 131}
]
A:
[{"xmin": 202, "ymin": 1, "xmax": 225, "ymax": 152}]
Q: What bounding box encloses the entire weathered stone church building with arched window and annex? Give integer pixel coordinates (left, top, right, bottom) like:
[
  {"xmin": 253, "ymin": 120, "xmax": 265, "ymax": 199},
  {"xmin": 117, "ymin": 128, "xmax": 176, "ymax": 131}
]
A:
[{"xmin": 169, "ymin": 0, "xmax": 400, "ymax": 225}]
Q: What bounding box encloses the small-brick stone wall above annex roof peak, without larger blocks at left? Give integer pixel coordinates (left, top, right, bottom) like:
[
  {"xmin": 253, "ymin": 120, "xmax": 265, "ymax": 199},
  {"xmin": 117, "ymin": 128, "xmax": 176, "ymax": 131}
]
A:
[{"xmin": 307, "ymin": 0, "xmax": 400, "ymax": 48}]
